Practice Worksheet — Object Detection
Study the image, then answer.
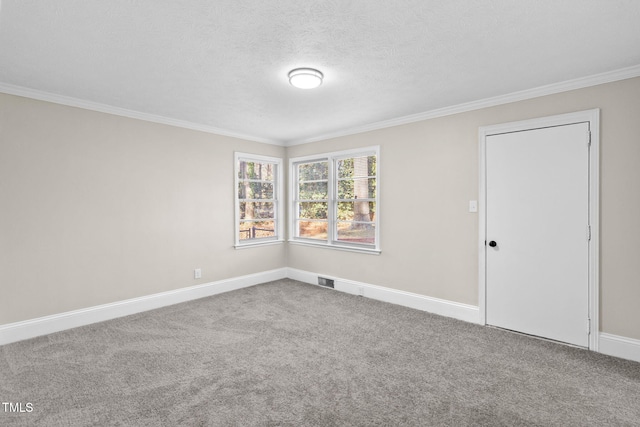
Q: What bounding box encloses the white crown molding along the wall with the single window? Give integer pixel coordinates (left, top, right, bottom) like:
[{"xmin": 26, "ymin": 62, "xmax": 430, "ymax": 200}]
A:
[{"xmin": 0, "ymin": 83, "xmax": 284, "ymax": 146}]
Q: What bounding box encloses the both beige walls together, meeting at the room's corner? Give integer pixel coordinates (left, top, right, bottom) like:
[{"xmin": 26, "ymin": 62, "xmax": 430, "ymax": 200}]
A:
[{"xmin": 0, "ymin": 78, "xmax": 640, "ymax": 339}]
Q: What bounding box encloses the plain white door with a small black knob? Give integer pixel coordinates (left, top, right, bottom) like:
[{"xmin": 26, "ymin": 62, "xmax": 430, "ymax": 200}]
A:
[{"xmin": 485, "ymin": 123, "xmax": 589, "ymax": 347}]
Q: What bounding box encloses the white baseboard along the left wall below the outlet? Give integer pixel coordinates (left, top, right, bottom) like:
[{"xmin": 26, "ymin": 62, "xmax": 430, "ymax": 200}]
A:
[{"xmin": 0, "ymin": 268, "xmax": 287, "ymax": 345}]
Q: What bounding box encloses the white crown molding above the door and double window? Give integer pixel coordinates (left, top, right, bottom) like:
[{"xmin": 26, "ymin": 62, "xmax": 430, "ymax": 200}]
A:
[{"xmin": 284, "ymin": 65, "xmax": 640, "ymax": 147}]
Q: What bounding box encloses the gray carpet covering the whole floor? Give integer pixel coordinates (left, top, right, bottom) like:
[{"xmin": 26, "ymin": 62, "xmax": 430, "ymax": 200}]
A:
[{"xmin": 0, "ymin": 280, "xmax": 640, "ymax": 426}]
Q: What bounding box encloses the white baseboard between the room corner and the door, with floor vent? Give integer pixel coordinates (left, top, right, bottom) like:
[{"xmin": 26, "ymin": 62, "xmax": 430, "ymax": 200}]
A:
[{"xmin": 287, "ymin": 268, "xmax": 479, "ymax": 324}]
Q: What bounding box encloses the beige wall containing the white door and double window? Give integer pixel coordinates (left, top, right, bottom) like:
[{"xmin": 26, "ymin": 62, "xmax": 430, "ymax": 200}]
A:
[{"xmin": 287, "ymin": 78, "xmax": 640, "ymax": 339}]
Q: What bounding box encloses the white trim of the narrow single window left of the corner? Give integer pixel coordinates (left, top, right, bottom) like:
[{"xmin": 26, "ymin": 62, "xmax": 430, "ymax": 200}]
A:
[{"xmin": 233, "ymin": 151, "xmax": 285, "ymax": 249}]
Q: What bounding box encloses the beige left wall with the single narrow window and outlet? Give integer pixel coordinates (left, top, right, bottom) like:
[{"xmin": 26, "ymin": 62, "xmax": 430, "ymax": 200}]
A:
[{"xmin": 0, "ymin": 94, "xmax": 285, "ymax": 324}]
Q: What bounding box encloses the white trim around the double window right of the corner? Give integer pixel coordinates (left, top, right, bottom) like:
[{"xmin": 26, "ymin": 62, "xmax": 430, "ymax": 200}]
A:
[{"xmin": 288, "ymin": 146, "xmax": 382, "ymax": 255}]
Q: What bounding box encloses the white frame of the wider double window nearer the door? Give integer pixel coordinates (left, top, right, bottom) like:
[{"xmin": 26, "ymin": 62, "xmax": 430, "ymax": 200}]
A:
[{"xmin": 288, "ymin": 146, "xmax": 381, "ymax": 254}]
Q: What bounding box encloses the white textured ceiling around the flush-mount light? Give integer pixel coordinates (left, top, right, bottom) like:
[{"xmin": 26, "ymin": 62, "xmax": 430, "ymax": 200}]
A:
[{"xmin": 0, "ymin": 0, "xmax": 640, "ymax": 145}]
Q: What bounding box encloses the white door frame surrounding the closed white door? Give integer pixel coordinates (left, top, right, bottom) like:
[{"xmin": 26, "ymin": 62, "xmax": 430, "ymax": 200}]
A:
[{"xmin": 478, "ymin": 108, "xmax": 600, "ymax": 351}]
